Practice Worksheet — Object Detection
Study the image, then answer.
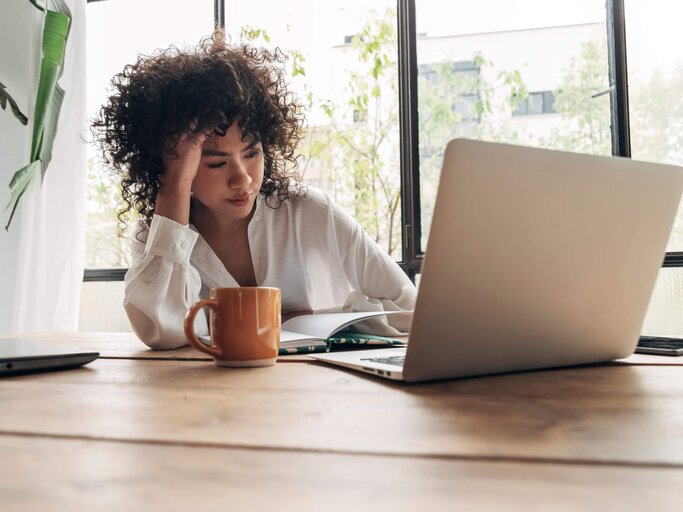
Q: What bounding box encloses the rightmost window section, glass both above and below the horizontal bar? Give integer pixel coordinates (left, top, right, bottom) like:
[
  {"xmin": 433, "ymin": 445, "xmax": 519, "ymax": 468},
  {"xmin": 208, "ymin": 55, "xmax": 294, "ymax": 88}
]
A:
[{"xmin": 624, "ymin": 0, "xmax": 683, "ymax": 336}]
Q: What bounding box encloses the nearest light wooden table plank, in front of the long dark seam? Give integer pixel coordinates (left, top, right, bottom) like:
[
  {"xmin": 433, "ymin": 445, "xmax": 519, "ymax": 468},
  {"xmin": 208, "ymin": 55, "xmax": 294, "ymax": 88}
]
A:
[{"xmin": 0, "ymin": 436, "xmax": 683, "ymax": 512}]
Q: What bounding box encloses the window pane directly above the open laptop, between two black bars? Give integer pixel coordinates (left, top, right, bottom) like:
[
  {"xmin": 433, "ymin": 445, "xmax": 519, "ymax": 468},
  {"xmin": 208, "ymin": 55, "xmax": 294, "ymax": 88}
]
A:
[{"xmin": 416, "ymin": 0, "xmax": 612, "ymax": 250}]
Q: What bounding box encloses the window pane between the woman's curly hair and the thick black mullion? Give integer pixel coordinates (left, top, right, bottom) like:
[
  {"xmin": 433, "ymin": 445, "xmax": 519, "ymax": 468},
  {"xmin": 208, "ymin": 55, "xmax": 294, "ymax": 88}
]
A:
[{"xmin": 225, "ymin": 0, "xmax": 404, "ymax": 259}]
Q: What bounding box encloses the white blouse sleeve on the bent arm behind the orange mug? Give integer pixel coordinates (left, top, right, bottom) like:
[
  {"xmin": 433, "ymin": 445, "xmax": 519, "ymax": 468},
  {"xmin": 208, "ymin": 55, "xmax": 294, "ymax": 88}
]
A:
[{"xmin": 123, "ymin": 215, "xmax": 208, "ymax": 350}]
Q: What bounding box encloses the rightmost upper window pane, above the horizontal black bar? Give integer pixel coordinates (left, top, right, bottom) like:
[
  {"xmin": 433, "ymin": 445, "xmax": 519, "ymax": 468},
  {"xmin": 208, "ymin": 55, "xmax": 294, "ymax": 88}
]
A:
[{"xmin": 624, "ymin": 0, "xmax": 683, "ymax": 251}]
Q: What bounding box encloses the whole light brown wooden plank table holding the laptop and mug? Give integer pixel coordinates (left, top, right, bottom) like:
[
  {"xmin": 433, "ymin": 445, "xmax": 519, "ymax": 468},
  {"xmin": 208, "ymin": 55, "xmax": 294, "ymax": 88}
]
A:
[{"xmin": 0, "ymin": 333, "xmax": 683, "ymax": 512}]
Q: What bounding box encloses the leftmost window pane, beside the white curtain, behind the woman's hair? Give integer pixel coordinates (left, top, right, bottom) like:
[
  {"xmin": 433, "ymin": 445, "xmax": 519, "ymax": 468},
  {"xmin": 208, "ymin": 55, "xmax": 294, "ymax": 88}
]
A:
[{"xmin": 85, "ymin": 0, "xmax": 214, "ymax": 268}]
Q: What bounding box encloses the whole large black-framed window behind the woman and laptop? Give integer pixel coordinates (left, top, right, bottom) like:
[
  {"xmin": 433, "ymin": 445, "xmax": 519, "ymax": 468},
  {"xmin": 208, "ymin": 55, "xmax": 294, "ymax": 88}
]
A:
[{"xmin": 88, "ymin": 0, "xmax": 683, "ymax": 328}]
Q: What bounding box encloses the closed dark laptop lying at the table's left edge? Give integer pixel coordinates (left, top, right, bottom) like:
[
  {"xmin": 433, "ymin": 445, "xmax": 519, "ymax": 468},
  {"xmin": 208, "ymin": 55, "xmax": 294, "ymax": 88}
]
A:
[{"xmin": 0, "ymin": 338, "xmax": 99, "ymax": 376}]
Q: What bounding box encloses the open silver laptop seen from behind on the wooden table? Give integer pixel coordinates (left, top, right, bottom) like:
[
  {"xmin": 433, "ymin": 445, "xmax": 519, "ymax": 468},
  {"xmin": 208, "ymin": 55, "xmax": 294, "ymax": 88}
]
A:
[{"xmin": 311, "ymin": 139, "xmax": 683, "ymax": 382}]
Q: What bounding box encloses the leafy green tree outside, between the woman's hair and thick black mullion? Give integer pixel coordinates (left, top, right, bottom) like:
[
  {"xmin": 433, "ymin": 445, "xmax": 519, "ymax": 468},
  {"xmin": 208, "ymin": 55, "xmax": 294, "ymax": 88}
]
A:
[{"xmin": 307, "ymin": 9, "xmax": 401, "ymax": 257}]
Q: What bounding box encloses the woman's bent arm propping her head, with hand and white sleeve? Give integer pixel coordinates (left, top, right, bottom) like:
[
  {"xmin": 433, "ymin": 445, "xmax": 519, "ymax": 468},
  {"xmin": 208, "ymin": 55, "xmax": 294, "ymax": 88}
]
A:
[{"xmin": 124, "ymin": 133, "xmax": 208, "ymax": 349}]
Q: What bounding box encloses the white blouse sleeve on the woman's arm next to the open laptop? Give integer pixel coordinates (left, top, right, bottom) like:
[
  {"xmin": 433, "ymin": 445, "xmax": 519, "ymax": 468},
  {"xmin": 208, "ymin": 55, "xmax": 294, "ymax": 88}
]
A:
[{"xmin": 333, "ymin": 200, "xmax": 417, "ymax": 336}]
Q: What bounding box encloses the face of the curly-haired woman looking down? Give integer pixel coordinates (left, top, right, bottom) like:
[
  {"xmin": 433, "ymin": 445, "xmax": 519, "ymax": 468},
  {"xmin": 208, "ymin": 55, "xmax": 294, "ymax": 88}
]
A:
[{"xmin": 192, "ymin": 122, "xmax": 264, "ymax": 220}]
